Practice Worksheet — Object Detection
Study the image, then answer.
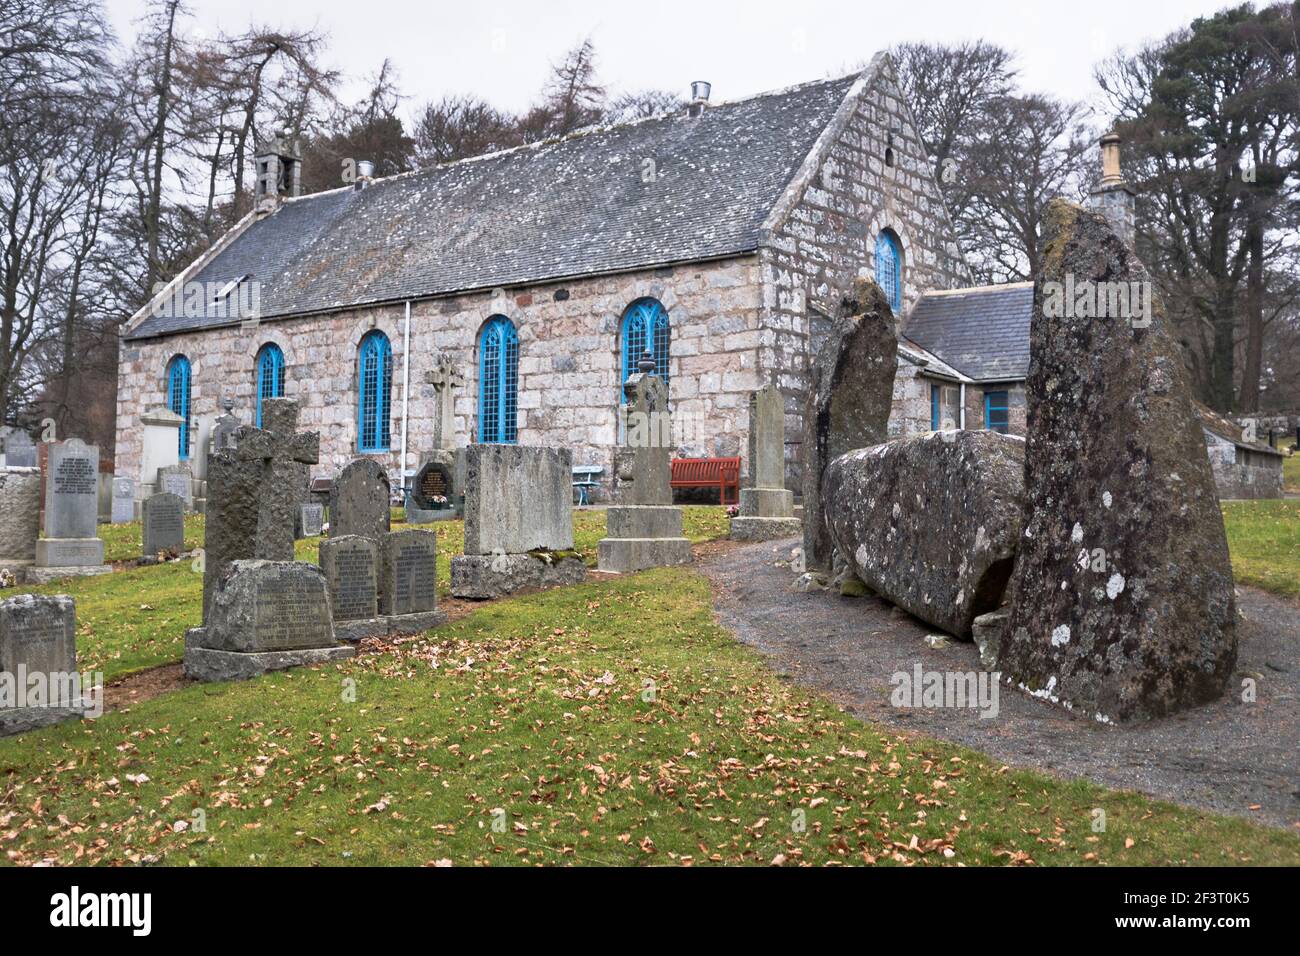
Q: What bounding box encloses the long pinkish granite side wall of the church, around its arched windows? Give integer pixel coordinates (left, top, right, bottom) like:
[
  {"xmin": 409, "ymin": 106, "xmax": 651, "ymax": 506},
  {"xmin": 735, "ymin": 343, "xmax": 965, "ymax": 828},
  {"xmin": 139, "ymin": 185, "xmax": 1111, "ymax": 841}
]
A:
[{"xmin": 117, "ymin": 256, "xmax": 761, "ymax": 494}]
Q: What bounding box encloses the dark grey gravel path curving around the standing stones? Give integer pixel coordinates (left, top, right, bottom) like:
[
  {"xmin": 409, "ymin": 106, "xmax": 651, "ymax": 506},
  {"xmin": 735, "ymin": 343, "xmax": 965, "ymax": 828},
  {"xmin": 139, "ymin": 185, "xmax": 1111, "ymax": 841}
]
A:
[{"xmin": 699, "ymin": 538, "xmax": 1300, "ymax": 827}]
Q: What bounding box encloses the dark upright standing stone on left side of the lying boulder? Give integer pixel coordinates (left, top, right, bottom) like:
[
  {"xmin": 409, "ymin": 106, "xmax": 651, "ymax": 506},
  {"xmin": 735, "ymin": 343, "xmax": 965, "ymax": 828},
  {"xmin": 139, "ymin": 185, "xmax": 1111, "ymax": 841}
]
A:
[{"xmin": 802, "ymin": 278, "xmax": 898, "ymax": 572}]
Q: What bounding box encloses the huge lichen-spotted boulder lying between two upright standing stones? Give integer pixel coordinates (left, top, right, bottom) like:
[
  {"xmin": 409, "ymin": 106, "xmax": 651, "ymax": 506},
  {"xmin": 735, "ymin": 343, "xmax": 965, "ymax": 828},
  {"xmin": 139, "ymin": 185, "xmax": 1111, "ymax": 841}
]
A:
[{"xmin": 822, "ymin": 432, "xmax": 1024, "ymax": 637}]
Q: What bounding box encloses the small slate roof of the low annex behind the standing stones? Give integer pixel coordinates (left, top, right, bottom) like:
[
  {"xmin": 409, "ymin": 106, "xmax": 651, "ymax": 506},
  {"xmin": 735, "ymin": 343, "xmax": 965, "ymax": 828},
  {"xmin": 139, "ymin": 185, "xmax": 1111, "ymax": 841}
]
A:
[{"xmin": 904, "ymin": 282, "xmax": 1034, "ymax": 382}]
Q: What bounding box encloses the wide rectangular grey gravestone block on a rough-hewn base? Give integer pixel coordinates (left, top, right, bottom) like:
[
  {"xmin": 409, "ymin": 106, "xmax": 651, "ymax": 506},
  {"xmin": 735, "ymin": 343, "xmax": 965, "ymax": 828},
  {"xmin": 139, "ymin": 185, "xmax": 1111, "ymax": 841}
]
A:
[{"xmin": 452, "ymin": 445, "xmax": 586, "ymax": 600}]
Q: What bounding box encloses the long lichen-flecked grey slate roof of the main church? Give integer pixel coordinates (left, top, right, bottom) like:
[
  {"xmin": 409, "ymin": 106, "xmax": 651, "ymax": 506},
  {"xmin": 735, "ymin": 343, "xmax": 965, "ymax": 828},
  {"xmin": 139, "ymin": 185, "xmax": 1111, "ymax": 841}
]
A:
[{"xmin": 129, "ymin": 74, "xmax": 858, "ymax": 338}]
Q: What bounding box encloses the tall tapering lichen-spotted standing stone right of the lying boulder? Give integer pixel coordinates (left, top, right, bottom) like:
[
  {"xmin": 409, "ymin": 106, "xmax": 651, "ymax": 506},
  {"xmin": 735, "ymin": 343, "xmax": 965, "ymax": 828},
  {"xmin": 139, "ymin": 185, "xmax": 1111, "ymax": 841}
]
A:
[{"xmin": 998, "ymin": 200, "xmax": 1236, "ymax": 721}]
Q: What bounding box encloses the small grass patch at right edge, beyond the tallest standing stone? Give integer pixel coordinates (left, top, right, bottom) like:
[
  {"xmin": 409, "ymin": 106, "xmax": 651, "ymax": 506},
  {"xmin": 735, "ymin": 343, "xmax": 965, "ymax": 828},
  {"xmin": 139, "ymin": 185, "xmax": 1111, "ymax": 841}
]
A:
[{"xmin": 1222, "ymin": 498, "xmax": 1300, "ymax": 598}]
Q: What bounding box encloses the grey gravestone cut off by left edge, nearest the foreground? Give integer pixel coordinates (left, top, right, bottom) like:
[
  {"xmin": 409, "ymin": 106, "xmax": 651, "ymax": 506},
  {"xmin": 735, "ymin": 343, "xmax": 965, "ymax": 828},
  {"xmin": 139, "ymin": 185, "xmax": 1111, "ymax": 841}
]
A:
[{"xmin": 0, "ymin": 594, "xmax": 90, "ymax": 736}]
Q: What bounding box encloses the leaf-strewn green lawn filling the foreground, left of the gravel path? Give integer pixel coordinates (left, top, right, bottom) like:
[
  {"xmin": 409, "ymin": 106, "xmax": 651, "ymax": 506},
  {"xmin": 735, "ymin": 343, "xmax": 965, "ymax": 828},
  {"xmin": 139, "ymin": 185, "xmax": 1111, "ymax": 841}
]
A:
[{"xmin": 0, "ymin": 568, "xmax": 1300, "ymax": 865}]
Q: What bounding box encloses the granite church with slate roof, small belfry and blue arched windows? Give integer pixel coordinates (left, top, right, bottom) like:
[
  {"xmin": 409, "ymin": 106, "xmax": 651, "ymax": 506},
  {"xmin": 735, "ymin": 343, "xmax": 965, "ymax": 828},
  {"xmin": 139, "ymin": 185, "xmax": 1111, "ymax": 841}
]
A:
[{"xmin": 117, "ymin": 55, "xmax": 977, "ymax": 488}]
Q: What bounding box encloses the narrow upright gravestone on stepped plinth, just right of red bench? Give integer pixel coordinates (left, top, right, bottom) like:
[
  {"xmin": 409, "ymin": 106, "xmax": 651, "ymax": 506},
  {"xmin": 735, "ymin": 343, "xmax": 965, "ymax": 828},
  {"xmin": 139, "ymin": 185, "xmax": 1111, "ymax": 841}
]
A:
[{"xmin": 731, "ymin": 385, "xmax": 803, "ymax": 541}]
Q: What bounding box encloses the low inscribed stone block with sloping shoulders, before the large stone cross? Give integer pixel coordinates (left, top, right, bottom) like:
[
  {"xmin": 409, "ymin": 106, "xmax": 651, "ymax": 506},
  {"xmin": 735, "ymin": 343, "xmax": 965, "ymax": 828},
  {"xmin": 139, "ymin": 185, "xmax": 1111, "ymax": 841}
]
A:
[{"xmin": 185, "ymin": 556, "xmax": 356, "ymax": 680}]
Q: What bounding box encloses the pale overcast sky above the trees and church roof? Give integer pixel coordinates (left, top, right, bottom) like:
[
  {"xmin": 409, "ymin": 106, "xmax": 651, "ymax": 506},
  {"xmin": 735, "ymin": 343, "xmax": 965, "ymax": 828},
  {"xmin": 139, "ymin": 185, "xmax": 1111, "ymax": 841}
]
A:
[{"xmin": 108, "ymin": 0, "xmax": 1226, "ymax": 119}]
